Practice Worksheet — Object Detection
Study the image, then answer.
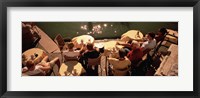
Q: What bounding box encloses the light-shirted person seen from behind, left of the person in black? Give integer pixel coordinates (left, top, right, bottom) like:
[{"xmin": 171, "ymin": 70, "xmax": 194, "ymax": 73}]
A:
[{"xmin": 64, "ymin": 42, "xmax": 80, "ymax": 60}]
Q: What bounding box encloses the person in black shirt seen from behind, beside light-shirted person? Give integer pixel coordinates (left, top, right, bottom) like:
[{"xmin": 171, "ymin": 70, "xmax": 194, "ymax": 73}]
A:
[{"xmin": 79, "ymin": 43, "xmax": 100, "ymax": 75}]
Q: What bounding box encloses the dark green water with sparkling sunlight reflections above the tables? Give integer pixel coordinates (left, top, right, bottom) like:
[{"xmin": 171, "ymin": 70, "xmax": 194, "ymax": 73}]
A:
[{"xmin": 36, "ymin": 22, "xmax": 178, "ymax": 39}]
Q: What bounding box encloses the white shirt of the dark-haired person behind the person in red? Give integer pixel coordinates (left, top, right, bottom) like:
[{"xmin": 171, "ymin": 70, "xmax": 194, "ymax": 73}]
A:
[{"xmin": 141, "ymin": 39, "xmax": 156, "ymax": 50}]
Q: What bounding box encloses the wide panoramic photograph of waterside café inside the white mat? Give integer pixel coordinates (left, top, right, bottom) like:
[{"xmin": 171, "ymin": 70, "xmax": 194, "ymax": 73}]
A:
[{"xmin": 21, "ymin": 21, "xmax": 178, "ymax": 76}]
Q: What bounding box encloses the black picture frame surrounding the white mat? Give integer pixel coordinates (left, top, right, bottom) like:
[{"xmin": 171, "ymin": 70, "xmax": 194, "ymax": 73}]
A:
[{"xmin": 0, "ymin": 0, "xmax": 200, "ymax": 98}]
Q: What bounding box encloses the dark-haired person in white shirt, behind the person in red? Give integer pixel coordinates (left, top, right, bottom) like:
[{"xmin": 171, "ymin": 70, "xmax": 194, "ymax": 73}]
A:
[{"xmin": 141, "ymin": 32, "xmax": 156, "ymax": 54}]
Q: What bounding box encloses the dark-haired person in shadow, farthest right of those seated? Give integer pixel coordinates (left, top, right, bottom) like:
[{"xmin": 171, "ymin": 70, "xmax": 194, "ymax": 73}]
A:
[{"xmin": 155, "ymin": 28, "xmax": 167, "ymax": 43}]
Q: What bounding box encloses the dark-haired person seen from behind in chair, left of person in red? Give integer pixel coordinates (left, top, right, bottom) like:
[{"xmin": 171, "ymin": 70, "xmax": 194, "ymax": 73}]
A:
[{"xmin": 108, "ymin": 49, "xmax": 131, "ymax": 76}]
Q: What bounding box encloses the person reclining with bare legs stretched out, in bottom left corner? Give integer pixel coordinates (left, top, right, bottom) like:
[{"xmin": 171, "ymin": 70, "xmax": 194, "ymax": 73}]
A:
[{"xmin": 22, "ymin": 56, "xmax": 60, "ymax": 76}]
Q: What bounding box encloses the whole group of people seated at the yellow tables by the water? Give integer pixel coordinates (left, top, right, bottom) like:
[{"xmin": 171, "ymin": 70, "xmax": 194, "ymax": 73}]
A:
[{"xmin": 22, "ymin": 28, "xmax": 167, "ymax": 76}]
